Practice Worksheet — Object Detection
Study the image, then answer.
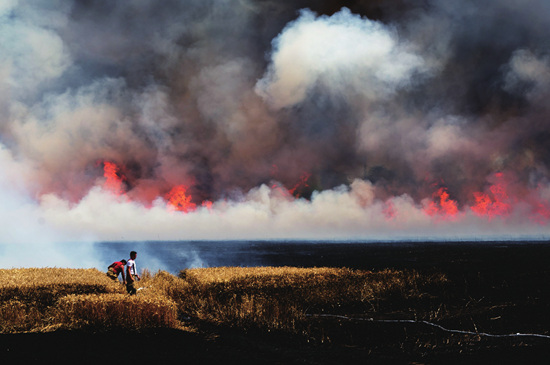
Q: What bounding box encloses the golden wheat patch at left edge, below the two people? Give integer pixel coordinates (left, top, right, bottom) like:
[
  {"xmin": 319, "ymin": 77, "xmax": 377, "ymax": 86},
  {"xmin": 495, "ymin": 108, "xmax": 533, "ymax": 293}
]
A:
[{"xmin": 0, "ymin": 268, "xmax": 177, "ymax": 333}]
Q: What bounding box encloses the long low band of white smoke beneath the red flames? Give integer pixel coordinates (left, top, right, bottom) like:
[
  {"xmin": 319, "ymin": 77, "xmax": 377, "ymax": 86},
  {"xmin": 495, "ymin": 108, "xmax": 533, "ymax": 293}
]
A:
[{"xmin": 35, "ymin": 176, "xmax": 546, "ymax": 240}]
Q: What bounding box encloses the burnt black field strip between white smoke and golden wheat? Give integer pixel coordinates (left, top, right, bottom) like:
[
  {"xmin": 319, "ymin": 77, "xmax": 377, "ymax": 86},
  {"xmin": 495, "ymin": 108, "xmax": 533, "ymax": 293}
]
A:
[{"xmin": 94, "ymin": 237, "xmax": 550, "ymax": 274}]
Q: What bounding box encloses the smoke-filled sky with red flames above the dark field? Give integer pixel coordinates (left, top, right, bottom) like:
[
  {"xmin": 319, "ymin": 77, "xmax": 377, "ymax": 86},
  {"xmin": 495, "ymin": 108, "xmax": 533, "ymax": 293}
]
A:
[{"xmin": 0, "ymin": 0, "xmax": 550, "ymax": 257}]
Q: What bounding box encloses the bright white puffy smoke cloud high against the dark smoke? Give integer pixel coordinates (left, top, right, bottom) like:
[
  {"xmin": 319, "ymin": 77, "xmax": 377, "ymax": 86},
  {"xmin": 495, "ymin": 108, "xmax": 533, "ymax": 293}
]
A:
[{"xmin": 257, "ymin": 8, "xmax": 426, "ymax": 108}]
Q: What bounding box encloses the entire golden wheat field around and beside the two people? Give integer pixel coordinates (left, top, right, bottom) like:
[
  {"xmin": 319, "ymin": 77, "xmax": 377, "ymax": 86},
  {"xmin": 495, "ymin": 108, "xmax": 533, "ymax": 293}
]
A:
[{"xmin": 0, "ymin": 267, "xmax": 446, "ymax": 333}]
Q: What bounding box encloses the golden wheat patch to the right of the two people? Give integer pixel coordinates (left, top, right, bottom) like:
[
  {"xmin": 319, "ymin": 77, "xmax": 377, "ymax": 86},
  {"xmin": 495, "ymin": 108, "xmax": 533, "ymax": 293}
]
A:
[{"xmin": 174, "ymin": 267, "xmax": 446, "ymax": 331}]
